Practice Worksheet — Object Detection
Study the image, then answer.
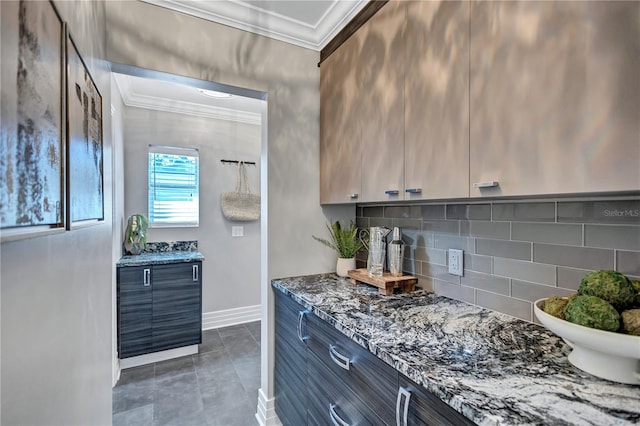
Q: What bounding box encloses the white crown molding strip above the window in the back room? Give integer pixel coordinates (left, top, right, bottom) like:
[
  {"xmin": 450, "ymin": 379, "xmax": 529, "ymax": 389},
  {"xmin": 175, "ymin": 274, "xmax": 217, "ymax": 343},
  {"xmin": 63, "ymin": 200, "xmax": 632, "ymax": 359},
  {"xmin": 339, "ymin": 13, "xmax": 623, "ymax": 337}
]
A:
[{"xmin": 114, "ymin": 75, "xmax": 262, "ymax": 126}]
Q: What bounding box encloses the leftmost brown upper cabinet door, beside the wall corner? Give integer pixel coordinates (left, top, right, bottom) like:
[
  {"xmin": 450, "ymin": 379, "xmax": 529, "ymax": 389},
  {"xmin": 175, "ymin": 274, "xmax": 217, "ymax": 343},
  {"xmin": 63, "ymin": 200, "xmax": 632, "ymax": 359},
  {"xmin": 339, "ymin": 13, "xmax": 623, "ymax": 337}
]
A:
[{"xmin": 320, "ymin": 21, "xmax": 362, "ymax": 204}]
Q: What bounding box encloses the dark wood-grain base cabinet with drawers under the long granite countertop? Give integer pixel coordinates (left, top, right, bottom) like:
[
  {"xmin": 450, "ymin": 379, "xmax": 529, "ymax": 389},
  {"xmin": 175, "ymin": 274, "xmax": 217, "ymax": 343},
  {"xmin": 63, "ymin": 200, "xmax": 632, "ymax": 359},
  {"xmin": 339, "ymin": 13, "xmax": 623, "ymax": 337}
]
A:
[{"xmin": 274, "ymin": 290, "xmax": 473, "ymax": 426}]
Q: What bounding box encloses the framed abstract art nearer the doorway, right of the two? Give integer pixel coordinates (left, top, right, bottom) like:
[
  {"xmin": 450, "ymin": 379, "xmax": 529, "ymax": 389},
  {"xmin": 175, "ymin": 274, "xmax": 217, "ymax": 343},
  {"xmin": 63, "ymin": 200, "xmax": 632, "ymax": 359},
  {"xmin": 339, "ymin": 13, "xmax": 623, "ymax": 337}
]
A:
[{"xmin": 67, "ymin": 34, "xmax": 104, "ymax": 229}]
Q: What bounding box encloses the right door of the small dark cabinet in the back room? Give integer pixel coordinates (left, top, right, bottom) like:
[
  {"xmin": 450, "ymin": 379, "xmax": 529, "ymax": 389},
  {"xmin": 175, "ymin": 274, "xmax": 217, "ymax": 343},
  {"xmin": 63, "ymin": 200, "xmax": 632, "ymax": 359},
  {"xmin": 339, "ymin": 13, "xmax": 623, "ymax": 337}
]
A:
[{"xmin": 152, "ymin": 262, "xmax": 202, "ymax": 351}]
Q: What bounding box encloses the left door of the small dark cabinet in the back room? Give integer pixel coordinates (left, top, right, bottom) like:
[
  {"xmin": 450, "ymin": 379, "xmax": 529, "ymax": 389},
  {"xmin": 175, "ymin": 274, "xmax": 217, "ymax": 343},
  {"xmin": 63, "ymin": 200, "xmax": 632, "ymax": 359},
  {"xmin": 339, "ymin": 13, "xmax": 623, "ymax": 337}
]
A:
[{"xmin": 117, "ymin": 266, "xmax": 153, "ymax": 358}]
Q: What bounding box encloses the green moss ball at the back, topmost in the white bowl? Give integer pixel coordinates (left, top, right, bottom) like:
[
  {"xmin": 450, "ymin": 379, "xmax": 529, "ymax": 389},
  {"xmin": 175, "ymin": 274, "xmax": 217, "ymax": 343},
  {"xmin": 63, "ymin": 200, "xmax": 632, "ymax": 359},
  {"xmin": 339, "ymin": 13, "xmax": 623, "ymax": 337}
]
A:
[{"xmin": 578, "ymin": 270, "xmax": 636, "ymax": 311}]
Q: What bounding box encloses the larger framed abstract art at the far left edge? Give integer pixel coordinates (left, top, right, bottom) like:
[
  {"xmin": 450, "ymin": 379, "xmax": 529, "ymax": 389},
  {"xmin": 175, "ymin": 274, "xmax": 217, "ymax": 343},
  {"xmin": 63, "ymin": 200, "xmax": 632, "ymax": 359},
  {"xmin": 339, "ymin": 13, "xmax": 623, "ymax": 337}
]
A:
[{"xmin": 0, "ymin": 1, "xmax": 66, "ymax": 242}]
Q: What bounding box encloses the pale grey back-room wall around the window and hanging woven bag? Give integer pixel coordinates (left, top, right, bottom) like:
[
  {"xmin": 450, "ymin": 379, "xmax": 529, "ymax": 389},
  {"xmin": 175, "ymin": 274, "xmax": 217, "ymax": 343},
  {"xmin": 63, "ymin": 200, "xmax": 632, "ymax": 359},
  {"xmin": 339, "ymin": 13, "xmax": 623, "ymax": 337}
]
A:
[{"xmin": 124, "ymin": 107, "xmax": 261, "ymax": 313}]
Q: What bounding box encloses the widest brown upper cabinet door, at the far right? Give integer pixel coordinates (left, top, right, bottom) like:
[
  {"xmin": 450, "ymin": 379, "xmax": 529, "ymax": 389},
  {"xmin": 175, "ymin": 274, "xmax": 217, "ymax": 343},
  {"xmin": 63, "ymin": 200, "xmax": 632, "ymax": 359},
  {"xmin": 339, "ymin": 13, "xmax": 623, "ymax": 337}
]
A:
[{"xmin": 470, "ymin": 1, "xmax": 640, "ymax": 197}]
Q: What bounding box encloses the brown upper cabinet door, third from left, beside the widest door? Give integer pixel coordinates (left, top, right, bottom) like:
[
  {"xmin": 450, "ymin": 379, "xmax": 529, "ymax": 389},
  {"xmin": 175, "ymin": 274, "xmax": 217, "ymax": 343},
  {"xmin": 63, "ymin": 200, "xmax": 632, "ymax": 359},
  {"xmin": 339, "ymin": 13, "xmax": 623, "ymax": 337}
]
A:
[{"xmin": 404, "ymin": 1, "xmax": 470, "ymax": 199}]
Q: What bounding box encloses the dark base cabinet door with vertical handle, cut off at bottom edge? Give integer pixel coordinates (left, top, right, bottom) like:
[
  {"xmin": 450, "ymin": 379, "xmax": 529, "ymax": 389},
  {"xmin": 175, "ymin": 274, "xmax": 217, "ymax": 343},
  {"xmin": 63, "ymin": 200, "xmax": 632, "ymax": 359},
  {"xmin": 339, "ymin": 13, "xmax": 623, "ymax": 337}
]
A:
[{"xmin": 398, "ymin": 374, "xmax": 475, "ymax": 426}]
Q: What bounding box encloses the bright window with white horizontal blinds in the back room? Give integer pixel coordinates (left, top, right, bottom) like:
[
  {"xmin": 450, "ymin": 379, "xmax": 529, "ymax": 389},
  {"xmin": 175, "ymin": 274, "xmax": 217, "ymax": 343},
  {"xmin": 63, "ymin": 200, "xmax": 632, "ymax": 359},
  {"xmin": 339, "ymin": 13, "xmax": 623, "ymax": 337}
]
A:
[{"xmin": 149, "ymin": 145, "xmax": 200, "ymax": 227}]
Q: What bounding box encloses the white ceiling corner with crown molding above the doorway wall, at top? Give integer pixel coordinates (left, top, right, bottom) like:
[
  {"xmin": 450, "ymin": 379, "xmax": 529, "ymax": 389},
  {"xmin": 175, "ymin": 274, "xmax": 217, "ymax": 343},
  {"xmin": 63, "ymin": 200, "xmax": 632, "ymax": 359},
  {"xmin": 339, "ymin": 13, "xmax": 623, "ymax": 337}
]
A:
[{"xmin": 142, "ymin": 0, "xmax": 368, "ymax": 51}]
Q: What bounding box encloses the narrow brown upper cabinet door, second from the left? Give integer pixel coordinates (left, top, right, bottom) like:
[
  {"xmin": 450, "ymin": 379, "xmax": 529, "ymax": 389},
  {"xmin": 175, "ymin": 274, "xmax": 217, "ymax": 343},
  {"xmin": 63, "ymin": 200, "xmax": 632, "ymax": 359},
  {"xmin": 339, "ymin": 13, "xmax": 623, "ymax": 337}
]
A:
[{"xmin": 356, "ymin": 1, "xmax": 406, "ymax": 201}]
